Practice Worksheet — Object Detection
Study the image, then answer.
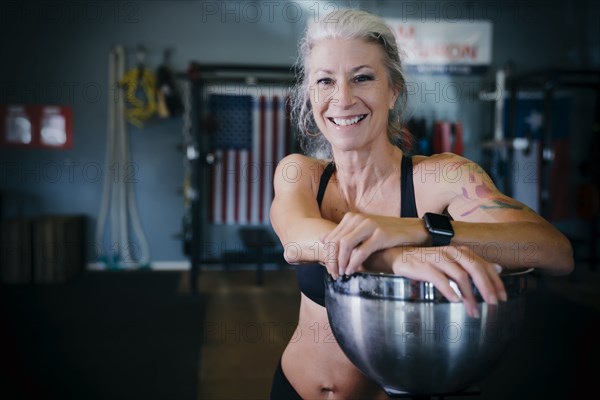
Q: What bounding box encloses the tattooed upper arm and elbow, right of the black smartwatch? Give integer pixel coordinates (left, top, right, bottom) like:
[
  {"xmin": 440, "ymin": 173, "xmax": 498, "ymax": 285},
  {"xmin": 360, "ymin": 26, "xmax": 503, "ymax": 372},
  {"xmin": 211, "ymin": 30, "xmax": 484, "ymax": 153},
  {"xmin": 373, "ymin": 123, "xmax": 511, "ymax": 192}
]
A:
[{"xmin": 441, "ymin": 154, "xmax": 574, "ymax": 274}]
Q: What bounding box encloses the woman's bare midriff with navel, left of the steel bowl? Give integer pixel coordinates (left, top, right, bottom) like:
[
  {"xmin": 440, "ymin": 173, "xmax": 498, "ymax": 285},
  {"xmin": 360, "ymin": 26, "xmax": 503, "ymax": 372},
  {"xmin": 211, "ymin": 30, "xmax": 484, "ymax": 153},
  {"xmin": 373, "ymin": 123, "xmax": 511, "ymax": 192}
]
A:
[{"xmin": 281, "ymin": 294, "xmax": 388, "ymax": 399}]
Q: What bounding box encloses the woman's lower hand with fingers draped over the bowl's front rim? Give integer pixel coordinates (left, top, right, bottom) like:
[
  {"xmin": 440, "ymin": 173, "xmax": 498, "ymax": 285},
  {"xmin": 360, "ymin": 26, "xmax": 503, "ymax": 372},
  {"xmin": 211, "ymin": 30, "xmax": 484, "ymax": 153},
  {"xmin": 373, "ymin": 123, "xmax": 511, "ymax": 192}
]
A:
[{"xmin": 365, "ymin": 246, "xmax": 507, "ymax": 318}]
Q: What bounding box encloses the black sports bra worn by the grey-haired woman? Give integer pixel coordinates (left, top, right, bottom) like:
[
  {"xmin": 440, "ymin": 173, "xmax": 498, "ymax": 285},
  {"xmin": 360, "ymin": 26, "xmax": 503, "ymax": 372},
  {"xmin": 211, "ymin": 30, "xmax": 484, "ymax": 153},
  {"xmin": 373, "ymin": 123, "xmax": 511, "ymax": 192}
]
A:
[{"xmin": 296, "ymin": 155, "xmax": 419, "ymax": 307}]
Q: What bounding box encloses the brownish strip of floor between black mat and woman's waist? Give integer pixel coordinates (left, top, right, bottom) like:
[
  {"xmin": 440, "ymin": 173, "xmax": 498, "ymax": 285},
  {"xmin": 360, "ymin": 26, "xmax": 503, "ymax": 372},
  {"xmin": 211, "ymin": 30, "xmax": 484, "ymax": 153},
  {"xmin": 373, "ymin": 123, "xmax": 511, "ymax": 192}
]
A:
[{"xmin": 189, "ymin": 268, "xmax": 300, "ymax": 400}]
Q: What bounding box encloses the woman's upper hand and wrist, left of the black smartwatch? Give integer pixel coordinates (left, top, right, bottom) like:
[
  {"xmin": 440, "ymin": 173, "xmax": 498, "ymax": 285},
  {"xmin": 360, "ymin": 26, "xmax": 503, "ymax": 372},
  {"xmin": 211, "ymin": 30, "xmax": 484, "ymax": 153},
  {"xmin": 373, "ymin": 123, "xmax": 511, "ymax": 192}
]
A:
[{"xmin": 321, "ymin": 212, "xmax": 427, "ymax": 276}]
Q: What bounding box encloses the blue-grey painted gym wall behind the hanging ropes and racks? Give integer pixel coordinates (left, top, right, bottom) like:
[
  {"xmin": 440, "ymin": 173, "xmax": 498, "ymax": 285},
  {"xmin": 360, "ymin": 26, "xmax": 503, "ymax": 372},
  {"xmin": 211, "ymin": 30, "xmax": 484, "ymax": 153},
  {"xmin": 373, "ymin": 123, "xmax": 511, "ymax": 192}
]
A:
[{"xmin": 0, "ymin": 1, "xmax": 600, "ymax": 261}]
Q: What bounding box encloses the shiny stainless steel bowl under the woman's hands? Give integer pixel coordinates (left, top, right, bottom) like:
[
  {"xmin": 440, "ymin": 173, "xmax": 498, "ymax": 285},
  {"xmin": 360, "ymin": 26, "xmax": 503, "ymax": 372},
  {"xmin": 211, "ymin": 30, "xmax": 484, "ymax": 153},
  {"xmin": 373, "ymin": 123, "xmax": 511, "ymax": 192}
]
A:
[{"xmin": 325, "ymin": 270, "xmax": 530, "ymax": 397}]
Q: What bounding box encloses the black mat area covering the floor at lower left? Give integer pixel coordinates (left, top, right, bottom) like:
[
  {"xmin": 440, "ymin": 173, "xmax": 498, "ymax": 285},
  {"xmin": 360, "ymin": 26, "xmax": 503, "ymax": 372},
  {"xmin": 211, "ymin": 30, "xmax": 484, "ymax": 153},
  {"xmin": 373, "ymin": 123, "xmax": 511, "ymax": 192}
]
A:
[{"xmin": 0, "ymin": 271, "xmax": 205, "ymax": 400}]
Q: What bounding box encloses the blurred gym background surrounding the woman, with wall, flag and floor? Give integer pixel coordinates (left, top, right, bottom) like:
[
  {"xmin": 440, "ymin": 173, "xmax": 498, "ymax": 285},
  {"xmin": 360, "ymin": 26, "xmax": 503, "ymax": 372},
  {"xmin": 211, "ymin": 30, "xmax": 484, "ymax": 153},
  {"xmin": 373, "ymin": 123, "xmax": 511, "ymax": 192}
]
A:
[{"xmin": 0, "ymin": 0, "xmax": 600, "ymax": 399}]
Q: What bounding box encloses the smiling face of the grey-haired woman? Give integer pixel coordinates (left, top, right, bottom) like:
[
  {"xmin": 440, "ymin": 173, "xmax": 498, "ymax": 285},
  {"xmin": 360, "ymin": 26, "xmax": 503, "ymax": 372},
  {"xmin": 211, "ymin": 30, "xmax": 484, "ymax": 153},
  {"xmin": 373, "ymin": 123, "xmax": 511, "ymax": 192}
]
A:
[{"xmin": 308, "ymin": 39, "xmax": 398, "ymax": 151}]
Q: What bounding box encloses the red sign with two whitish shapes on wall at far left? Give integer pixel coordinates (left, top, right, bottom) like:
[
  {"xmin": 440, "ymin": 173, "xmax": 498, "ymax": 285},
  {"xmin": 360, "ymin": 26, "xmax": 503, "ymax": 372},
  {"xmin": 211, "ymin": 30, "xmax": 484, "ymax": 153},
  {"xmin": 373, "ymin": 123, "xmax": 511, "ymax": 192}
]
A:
[{"xmin": 0, "ymin": 105, "xmax": 73, "ymax": 149}]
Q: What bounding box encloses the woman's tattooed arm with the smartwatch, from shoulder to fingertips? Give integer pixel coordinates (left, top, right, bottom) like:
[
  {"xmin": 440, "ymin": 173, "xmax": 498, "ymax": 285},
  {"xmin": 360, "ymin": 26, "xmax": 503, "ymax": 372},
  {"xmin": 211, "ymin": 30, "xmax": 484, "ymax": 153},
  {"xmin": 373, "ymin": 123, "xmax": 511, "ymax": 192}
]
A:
[{"xmin": 321, "ymin": 153, "xmax": 573, "ymax": 274}]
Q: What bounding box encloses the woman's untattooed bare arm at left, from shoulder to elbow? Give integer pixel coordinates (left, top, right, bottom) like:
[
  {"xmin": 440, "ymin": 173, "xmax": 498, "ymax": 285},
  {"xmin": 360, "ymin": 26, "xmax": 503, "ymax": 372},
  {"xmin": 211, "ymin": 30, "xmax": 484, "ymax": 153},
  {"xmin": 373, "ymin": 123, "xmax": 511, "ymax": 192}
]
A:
[{"xmin": 270, "ymin": 154, "xmax": 337, "ymax": 276}]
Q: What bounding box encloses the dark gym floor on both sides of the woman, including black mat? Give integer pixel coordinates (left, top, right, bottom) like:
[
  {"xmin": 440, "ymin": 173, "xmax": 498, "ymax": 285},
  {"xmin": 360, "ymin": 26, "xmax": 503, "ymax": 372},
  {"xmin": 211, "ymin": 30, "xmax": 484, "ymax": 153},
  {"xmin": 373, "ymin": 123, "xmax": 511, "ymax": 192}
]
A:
[{"xmin": 0, "ymin": 264, "xmax": 600, "ymax": 400}]
